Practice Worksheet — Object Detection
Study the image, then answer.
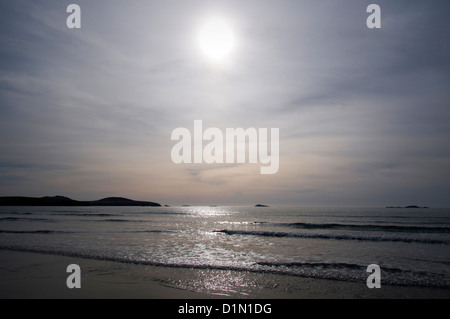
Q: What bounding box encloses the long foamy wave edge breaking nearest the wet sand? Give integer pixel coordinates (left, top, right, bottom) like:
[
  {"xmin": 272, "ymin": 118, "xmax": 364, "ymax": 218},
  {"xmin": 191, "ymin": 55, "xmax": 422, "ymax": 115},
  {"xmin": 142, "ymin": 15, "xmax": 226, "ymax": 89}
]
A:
[{"xmin": 0, "ymin": 245, "xmax": 450, "ymax": 289}]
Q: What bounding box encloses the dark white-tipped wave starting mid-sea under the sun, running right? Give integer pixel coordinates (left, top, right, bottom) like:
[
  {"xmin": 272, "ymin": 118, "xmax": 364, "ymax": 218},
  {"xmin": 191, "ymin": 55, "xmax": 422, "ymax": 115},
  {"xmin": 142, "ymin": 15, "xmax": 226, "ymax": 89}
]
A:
[{"xmin": 213, "ymin": 229, "xmax": 448, "ymax": 245}]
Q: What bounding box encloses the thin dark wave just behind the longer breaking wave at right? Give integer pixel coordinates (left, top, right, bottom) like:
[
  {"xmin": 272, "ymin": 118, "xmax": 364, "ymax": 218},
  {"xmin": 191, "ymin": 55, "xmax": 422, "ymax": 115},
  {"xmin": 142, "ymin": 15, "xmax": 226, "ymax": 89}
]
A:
[{"xmin": 277, "ymin": 223, "xmax": 450, "ymax": 233}]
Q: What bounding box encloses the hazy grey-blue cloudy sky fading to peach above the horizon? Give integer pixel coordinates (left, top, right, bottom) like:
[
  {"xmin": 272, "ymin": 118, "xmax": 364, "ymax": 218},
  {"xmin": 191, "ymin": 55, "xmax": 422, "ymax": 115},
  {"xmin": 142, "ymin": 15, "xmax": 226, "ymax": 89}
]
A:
[{"xmin": 0, "ymin": 0, "xmax": 450, "ymax": 207}]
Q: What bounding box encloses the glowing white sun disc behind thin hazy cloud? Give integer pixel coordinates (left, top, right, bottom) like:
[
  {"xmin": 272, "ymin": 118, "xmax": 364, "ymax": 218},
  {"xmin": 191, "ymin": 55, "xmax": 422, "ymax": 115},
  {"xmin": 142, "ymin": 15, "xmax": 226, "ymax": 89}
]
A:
[{"xmin": 198, "ymin": 18, "xmax": 235, "ymax": 62}]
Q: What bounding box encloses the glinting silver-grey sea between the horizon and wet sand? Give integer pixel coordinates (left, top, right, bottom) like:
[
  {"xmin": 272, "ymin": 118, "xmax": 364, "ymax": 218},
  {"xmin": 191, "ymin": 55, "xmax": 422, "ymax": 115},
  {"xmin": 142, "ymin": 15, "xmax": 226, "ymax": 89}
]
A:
[{"xmin": 0, "ymin": 206, "xmax": 450, "ymax": 289}]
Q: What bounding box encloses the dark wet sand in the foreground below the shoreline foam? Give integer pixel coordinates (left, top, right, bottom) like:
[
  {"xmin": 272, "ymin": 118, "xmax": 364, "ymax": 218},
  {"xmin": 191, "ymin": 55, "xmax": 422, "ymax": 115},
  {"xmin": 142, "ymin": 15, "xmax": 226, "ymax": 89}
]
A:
[{"xmin": 0, "ymin": 250, "xmax": 450, "ymax": 299}]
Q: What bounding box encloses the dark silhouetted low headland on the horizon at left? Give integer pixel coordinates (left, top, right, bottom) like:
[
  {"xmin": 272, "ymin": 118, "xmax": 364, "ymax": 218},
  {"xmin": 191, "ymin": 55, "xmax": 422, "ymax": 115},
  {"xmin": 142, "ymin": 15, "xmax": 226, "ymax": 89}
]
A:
[{"xmin": 0, "ymin": 196, "xmax": 161, "ymax": 206}]
